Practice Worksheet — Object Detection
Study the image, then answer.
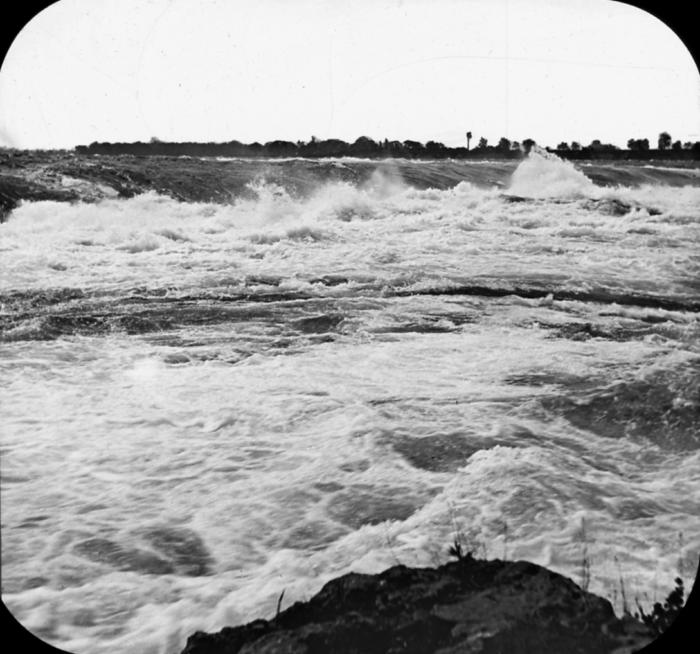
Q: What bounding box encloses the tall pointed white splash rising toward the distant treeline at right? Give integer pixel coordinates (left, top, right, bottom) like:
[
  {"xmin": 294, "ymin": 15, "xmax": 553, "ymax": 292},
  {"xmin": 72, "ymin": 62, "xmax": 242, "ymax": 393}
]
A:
[{"xmin": 508, "ymin": 146, "xmax": 598, "ymax": 198}]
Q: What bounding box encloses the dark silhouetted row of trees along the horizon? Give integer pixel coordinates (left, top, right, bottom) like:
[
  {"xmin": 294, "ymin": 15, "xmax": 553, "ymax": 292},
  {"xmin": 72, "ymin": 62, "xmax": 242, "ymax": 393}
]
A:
[{"xmin": 75, "ymin": 132, "xmax": 700, "ymax": 159}]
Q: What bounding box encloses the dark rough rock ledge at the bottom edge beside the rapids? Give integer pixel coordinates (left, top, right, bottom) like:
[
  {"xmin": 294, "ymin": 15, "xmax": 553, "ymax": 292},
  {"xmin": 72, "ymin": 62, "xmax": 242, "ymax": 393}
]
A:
[{"xmin": 182, "ymin": 556, "xmax": 654, "ymax": 654}]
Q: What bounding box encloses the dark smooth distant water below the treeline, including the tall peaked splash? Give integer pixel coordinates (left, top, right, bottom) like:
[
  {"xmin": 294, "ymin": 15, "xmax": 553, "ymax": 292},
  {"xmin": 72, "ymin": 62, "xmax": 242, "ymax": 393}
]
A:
[{"xmin": 5, "ymin": 152, "xmax": 700, "ymax": 222}]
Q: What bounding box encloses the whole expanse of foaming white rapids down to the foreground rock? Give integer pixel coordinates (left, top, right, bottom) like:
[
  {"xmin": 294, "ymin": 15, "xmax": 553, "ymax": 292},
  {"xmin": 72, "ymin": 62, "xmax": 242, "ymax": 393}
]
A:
[{"xmin": 0, "ymin": 153, "xmax": 700, "ymax": 654}]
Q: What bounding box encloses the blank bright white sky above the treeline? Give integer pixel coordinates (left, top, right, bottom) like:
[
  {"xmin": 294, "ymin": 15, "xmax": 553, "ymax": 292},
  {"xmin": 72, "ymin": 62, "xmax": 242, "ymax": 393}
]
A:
[{"xmin": 0, "ymin": 0, "xmax": 700, "ymax": 148}]
